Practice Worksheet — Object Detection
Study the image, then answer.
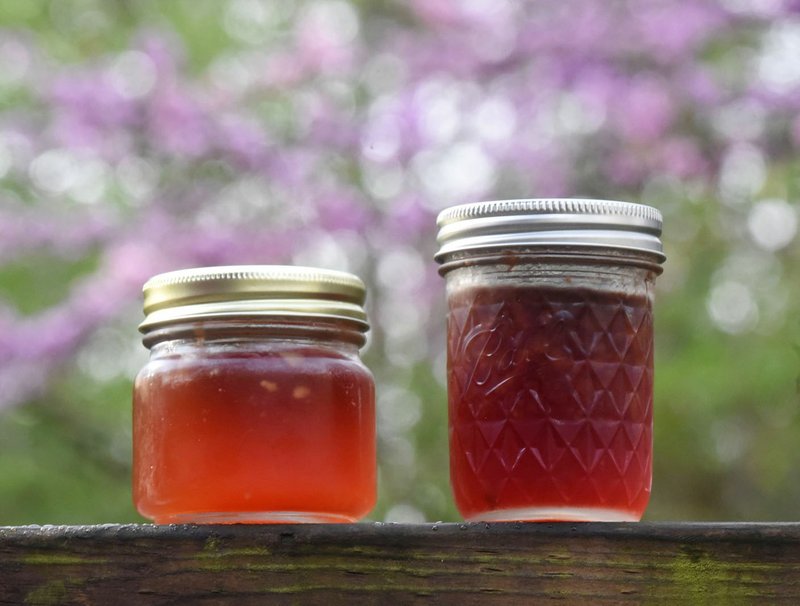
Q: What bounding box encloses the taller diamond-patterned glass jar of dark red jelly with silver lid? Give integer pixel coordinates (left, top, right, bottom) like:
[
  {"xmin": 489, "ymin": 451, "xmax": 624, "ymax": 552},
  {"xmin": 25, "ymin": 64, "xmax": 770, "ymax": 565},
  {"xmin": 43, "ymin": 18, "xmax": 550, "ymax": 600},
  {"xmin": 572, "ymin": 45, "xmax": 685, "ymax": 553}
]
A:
[{"xmin": 436, "ymin": 199, "xmax": 665, "ymax": 521}]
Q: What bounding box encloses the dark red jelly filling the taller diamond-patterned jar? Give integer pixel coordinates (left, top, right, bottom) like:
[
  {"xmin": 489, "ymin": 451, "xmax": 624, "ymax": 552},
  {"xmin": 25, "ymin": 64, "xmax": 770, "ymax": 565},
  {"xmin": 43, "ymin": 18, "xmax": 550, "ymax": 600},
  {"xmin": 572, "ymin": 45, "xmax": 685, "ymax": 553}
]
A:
[{"xmin": 448, "ymin": 286, "xmax": 653, "ymax": 520}]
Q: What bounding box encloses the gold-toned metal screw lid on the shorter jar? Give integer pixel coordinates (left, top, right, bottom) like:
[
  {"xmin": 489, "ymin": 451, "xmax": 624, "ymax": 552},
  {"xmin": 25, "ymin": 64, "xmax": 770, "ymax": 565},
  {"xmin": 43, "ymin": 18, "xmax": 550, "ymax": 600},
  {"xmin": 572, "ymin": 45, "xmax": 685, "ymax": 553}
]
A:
[{"xmin": 139, "ymin": 265, "xmax": 369, "ymax": 333}]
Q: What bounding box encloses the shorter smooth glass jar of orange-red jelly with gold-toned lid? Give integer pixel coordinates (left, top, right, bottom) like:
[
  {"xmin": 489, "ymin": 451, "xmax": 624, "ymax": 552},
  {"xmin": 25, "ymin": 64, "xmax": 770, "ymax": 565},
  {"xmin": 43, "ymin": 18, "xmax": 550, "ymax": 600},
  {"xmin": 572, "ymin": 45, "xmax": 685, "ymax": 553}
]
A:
[{"xmin": 133, "ymin": 266, "xmax": 376, "ymax": 524}]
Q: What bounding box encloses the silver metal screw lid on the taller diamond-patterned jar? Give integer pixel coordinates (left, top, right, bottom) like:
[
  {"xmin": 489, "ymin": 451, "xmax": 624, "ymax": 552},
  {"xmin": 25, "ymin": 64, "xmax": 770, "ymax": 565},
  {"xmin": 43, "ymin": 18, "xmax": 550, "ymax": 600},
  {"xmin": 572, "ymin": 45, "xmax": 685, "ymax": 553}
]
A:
[{"xmin": 435, "ymin": 198, "xmax": 666, "ymax": 263}]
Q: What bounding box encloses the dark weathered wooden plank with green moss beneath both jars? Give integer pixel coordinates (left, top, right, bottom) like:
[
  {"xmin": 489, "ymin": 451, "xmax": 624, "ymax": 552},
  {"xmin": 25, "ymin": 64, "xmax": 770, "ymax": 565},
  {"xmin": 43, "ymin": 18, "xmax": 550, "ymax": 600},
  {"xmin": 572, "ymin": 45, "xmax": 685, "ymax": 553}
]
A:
[{"xmin": 0, "ymin": 523, "xmax": 800, "ymax": 606}]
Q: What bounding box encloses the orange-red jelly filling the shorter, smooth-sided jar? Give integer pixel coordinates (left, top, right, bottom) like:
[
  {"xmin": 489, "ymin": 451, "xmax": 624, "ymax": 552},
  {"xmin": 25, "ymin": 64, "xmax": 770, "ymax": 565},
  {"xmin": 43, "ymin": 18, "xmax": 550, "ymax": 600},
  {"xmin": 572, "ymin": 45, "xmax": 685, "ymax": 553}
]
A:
[{"xmin": 133, "ymin": 346, "xmax": 376, "ymax": 523}]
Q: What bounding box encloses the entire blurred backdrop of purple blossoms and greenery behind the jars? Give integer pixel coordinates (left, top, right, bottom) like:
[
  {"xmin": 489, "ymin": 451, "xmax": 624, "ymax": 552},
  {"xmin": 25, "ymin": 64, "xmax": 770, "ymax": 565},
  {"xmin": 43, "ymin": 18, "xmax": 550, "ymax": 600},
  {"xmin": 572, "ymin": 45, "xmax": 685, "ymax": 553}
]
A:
[{"xmin": 0, "ymin": 0, "xmax": 800, "ymax": 524}]
